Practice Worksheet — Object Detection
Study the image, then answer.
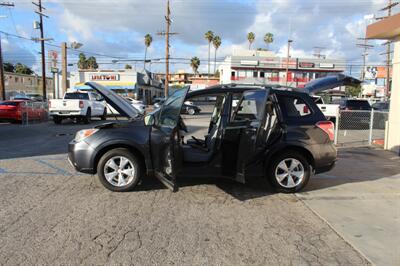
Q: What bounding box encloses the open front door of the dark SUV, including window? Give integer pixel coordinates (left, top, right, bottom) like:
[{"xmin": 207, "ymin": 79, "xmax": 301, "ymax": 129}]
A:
[{"xmin": 150, "ymin": 89, "xmax": 188, "ymax": 191}]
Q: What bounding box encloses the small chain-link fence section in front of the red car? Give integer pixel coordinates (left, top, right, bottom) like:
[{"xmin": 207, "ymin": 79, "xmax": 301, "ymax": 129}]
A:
[{"xmin": 21, "ymin": 102, "xmax": 49, "ymax": 125}]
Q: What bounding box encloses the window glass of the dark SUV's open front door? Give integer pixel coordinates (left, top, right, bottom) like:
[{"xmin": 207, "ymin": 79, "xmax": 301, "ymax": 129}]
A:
[{"xmin": 158, "ymin": 89, "xmax": 187, "ymax": 129}]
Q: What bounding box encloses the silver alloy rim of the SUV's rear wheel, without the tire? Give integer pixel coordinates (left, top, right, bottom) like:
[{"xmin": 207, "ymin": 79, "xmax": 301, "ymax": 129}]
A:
[{"xmin": 275, "ymin": 158, "xmax": 304, "ymax": 188}]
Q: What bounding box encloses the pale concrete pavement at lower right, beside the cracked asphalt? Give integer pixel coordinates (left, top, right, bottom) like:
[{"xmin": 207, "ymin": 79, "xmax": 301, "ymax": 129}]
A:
[{"xmin": 297, "ymin": 148, "xmax": 400, "ymax": 265}]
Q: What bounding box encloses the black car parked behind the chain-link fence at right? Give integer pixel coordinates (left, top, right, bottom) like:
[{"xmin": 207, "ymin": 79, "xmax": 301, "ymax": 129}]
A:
[{"xmin": 333, "ymin": 98, "xmax": 372, "ymax": 130}]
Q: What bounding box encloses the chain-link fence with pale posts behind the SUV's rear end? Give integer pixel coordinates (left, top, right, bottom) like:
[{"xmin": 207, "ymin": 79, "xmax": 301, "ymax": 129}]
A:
[{"xmin": 335, "ymin": 110, "xmax": 389, "ymax": 146}]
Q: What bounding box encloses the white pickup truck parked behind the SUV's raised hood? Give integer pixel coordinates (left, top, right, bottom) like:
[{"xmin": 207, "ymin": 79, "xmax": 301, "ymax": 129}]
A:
[{"xmin": 49, "ymin": 91, "xmax": 107, "ymax": 124}]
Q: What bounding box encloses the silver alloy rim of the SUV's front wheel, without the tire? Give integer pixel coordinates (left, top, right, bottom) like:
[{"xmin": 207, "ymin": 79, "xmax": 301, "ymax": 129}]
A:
[{"xmin": 104, "ymin": 156, "xmax": 136, "ymax": 187}]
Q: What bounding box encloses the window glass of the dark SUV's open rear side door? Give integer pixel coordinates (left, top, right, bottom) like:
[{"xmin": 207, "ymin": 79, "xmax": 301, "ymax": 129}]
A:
[{"xmin": 233, "ymin": 90, "xmax": 265, "ymax": 121}]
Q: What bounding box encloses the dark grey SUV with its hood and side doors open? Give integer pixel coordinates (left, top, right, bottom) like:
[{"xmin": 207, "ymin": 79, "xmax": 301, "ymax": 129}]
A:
[{"xmin": 68, "ymin": 76, "xmax": 358, "ymax": 192}]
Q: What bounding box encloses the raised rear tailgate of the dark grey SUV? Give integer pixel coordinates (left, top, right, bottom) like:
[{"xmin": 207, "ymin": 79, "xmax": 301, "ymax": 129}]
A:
[{"xmin": 304, "ymin": 74, "xmax": 361, "ymax": 94}]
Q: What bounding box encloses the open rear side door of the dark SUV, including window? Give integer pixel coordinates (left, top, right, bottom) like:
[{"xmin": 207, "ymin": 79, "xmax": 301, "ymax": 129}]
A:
[{"xmin": 222, "ymin": 89, "xmax": 269, "ymax": 183}]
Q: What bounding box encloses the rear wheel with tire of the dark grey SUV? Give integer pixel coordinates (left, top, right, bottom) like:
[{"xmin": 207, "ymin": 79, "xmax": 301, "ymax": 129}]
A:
[{"xmin": 267, "ymin": 151, "xmax": 311, "ymax": 193}]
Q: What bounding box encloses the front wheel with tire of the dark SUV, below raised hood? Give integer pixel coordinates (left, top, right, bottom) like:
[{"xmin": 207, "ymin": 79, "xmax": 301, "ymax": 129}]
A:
[{"xmin": 97, "ymin": 148, "xmax": 142, "ymax": 192}]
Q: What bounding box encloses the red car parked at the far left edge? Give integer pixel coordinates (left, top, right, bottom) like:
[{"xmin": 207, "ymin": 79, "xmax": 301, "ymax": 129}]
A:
[{"xmin": 0, "ymin": 100, "xmax": 46, "ymax": 122}]
